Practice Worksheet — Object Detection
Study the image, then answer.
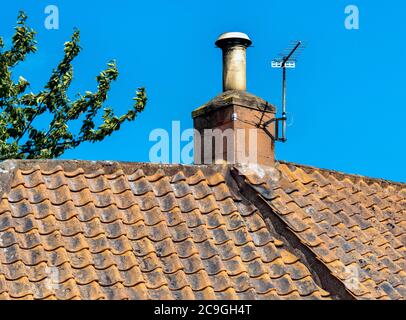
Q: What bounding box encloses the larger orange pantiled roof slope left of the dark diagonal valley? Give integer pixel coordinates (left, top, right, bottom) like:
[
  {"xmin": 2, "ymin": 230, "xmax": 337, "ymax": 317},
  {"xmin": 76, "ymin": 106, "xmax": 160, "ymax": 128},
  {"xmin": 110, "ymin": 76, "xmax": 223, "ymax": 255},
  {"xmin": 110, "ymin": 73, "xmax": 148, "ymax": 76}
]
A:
[{"xmin": 0, "ymin": 161, "xmax": 330, "ymax": 299}]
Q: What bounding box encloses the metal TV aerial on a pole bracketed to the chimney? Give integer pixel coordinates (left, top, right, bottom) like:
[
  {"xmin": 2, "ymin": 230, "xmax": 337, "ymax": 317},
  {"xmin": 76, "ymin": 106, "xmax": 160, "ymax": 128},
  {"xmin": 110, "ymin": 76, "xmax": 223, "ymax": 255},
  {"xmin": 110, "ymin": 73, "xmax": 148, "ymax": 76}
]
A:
[{"xmin": 258, "ymin": 41, "xmax": 305, "ymax": 142}]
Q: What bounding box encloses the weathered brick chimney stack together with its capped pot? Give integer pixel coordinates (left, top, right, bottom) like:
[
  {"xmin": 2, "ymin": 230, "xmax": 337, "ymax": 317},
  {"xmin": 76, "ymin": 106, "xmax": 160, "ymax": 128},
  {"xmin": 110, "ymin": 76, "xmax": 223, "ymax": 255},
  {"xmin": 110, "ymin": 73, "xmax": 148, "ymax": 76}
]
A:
[{"xmin": 192, "ymin": 32, "xmax": 276, "ymax": 166}]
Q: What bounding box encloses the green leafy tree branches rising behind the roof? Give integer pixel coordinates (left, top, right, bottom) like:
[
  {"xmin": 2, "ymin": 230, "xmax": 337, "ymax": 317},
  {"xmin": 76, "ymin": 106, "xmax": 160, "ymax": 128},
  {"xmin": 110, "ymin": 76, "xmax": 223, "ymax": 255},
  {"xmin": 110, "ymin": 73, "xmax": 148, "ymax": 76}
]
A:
[{"xmin": 0, "ymin": 12, "xmax": 147, "ymax": 160}]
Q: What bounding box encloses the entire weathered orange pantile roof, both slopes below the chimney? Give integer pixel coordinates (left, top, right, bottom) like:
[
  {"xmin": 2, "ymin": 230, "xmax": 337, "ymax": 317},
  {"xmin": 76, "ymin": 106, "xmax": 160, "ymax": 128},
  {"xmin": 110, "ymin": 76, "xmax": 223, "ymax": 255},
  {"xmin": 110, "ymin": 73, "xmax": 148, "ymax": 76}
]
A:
[{"xmin": 0, "ymin": 161, "xmax": 406, "ymax": 299}]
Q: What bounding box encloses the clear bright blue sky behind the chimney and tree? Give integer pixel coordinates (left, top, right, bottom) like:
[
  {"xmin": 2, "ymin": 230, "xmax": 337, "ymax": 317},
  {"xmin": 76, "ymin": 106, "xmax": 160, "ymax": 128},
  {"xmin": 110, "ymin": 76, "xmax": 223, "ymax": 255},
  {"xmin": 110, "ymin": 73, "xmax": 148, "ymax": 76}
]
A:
[{"xmin": 0, "ymin": 0, "xmax": 406, "ymax": 182}]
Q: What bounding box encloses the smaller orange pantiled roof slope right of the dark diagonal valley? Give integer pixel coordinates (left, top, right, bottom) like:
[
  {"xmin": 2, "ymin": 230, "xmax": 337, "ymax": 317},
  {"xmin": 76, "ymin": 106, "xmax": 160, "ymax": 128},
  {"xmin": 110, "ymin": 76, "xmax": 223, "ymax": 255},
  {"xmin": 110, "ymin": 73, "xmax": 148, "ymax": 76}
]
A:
[{"xmin": 238, "ymin": 163, "xmax": 406, "ymax": 299}]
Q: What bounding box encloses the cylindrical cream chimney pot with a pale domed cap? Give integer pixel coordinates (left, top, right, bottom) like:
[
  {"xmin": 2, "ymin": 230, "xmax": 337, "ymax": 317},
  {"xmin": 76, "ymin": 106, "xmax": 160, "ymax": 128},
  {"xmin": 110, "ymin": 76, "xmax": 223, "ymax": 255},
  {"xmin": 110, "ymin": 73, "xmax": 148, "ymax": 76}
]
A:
[{"xmin": 216, "ymin": 32, "xmax": 252, "ymax": 92}]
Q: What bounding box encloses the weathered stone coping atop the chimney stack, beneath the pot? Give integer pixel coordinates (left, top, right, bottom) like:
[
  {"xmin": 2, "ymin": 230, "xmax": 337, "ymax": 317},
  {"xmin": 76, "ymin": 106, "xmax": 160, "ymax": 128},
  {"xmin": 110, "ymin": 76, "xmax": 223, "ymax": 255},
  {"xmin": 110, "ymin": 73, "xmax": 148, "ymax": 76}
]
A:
[{"xmin": 192, "ymin": 90, "xmax": 276, "ymax": 118}]
